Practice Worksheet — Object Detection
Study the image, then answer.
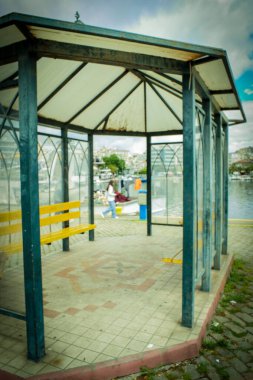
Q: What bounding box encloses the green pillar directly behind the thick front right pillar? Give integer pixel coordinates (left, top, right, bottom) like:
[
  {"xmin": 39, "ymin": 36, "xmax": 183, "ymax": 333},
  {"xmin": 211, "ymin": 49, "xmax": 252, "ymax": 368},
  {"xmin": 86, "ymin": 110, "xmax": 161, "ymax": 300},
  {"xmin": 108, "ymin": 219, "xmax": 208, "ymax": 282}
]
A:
[{"xmin": 202, "ymin": 99, "xmax": 213, "ymax": 292}]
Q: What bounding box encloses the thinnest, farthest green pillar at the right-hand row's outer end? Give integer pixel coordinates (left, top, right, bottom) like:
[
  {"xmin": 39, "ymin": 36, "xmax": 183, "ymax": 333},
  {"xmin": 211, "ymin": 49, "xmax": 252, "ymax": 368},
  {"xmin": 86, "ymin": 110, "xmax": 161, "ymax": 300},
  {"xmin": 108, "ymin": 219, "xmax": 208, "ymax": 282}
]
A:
[{"xmin": 222, "ymin": 124, "xmax": 229, "ymax": 255}]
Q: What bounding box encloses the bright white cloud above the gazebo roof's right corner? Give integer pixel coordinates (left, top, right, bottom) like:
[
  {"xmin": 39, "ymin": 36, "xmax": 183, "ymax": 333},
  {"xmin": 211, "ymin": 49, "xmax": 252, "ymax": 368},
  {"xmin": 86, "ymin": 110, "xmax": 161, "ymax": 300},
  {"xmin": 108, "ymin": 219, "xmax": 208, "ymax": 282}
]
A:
[{"xmin": 130, "ymin": 0, "xmax": 253, "ymax": 77}]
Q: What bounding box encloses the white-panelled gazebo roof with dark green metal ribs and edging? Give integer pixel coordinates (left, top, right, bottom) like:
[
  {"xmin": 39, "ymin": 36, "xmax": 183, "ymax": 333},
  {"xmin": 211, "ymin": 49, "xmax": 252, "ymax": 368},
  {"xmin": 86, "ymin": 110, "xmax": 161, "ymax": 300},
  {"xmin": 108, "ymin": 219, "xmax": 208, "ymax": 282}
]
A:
[{"xmin": 0, "ymin": 13, "xmax": 246, "ymax": 135}]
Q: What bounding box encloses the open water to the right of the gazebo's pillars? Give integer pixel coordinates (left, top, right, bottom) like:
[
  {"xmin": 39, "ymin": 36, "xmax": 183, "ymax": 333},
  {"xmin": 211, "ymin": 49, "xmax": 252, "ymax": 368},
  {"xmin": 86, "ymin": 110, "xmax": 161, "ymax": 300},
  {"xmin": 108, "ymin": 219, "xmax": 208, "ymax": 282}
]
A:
[{"xmin": 228, "ymin": 181, "xmax": 253, "ymax": 219}]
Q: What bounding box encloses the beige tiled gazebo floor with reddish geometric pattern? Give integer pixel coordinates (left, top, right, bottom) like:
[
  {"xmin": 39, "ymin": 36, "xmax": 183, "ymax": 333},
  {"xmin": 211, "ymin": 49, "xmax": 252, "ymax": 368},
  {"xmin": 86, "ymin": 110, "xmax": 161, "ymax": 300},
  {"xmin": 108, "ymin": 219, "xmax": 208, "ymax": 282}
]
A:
[{"xmin": 0, "ymin": 217, "xmax": 247, "ymax": 377}]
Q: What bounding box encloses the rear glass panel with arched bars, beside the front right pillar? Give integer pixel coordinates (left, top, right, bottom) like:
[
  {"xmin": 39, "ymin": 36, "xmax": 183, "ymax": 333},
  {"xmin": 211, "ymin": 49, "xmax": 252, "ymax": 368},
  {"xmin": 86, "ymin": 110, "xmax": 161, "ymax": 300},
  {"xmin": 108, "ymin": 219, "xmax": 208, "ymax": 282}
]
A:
[{"xmin": 151, "ymin": 143, "xmax": 183, "ymax": 224}]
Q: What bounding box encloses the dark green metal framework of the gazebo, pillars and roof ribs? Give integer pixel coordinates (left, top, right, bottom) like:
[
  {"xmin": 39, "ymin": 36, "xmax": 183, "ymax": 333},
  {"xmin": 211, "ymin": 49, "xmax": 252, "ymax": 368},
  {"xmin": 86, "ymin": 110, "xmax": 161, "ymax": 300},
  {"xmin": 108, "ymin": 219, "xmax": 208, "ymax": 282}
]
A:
[{"xmin": 0, "ymin": 14, "xmax": 236, "ymax": 360}]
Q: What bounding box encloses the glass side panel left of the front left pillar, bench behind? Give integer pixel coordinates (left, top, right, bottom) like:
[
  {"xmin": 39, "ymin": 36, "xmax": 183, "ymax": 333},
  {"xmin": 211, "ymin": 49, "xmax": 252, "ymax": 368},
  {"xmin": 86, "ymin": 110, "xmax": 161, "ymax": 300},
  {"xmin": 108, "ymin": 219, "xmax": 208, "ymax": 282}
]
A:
[{"xmin": 0, "ymin": 118, "xmax": 25, "ymax": 314}]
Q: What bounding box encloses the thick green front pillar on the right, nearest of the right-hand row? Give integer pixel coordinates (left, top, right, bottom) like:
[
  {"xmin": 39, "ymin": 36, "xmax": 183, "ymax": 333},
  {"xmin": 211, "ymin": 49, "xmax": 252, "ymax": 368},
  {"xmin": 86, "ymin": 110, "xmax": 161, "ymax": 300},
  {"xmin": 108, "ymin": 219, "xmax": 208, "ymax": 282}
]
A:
[{"xmin": 182, "ymin": 73, "xmax": 196, "ymax": 327}]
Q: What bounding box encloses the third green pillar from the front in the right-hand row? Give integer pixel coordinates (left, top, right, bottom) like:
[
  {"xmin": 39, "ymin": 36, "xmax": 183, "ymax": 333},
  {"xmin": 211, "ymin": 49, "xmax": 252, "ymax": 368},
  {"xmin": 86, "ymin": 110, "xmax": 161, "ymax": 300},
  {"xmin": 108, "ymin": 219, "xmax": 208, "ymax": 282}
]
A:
[{"xmin": 214, "ymin": 114, "xmax": 223, "ymax": 269}]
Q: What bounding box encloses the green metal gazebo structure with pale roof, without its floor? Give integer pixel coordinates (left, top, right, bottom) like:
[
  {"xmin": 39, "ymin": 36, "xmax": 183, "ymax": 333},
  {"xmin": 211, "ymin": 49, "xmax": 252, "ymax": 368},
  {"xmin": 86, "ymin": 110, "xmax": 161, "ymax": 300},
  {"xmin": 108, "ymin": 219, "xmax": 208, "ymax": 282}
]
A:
[{"xmin": 0, "ymin": 13, "xmax": 246, "ymax": 360}]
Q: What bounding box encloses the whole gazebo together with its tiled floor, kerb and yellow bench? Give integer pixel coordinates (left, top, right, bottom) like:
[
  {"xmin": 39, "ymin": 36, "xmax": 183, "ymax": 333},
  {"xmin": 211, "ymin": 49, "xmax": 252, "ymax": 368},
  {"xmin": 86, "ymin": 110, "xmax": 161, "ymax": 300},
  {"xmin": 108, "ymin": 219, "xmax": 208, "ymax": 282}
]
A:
[{"xmin": 0, "ymin": 13, "xmax": 246, "ymax": 379}]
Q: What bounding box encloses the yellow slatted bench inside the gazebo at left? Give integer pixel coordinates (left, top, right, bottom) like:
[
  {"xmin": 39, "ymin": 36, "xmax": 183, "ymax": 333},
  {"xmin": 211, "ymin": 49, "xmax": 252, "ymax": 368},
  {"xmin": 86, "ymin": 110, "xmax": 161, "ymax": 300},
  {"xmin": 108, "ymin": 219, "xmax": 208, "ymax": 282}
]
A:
[{"xmin": 0, "ymin": 201, "xmax": 96, "ymax": 253}]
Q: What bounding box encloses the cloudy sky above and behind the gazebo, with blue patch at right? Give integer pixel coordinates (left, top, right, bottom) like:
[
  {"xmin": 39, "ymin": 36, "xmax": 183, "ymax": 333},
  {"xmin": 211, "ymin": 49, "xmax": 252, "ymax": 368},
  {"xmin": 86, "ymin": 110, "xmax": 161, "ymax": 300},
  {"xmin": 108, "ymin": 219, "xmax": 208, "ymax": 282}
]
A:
[{"xmin": 0, "ymin": 0, "xmax": 253, "ymax": 153}]
